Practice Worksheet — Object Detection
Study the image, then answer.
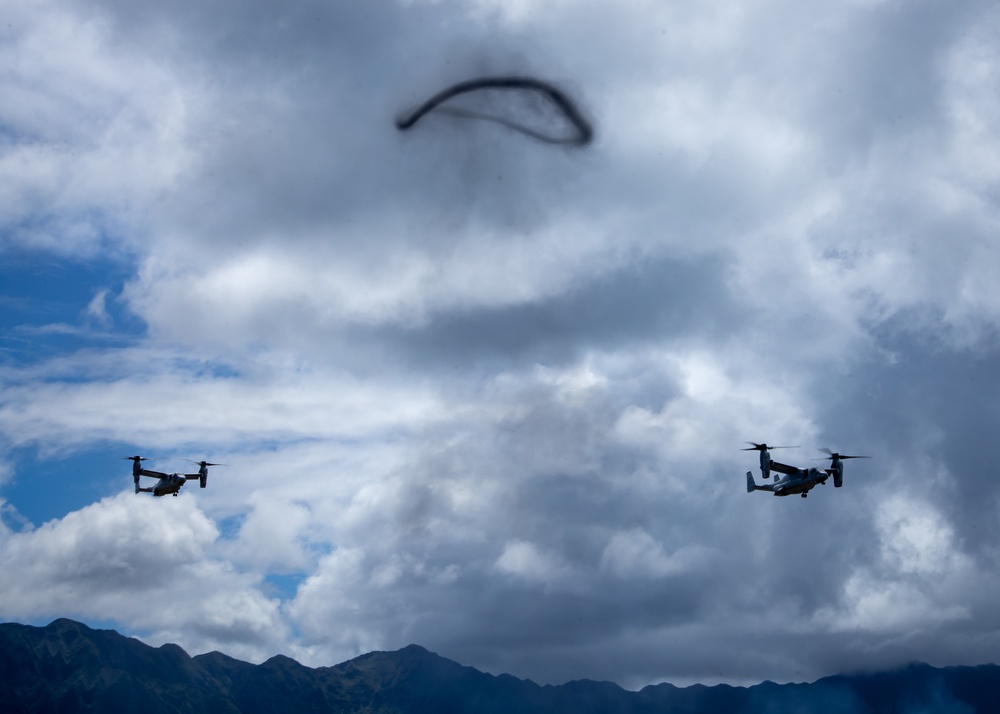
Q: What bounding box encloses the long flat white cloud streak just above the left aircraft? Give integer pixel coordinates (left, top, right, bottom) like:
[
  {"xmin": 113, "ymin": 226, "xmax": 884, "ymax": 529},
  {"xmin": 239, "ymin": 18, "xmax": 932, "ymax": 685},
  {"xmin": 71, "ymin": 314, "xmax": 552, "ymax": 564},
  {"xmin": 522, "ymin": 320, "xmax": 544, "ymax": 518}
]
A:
[{"xmin": 0, "ymin": 351, "xmax": 450, "ymax": 449}]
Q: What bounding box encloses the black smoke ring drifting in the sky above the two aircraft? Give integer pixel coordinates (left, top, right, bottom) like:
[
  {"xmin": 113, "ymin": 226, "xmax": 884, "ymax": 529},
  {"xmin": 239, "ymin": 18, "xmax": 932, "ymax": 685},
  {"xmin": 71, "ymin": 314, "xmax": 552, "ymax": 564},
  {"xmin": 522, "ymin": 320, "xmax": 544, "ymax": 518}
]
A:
[{"xmin": 396, "ymin": 77, "xmax": 594, "ymax": 146}]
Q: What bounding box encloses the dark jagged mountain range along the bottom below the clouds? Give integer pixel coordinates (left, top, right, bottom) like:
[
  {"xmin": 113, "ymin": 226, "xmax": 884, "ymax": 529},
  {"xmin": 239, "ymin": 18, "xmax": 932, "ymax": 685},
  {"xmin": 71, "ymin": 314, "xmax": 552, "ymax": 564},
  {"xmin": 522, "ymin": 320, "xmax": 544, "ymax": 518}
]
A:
[{"xmin": 0, "ymin": 619, "xmax": 1000, "ymax": 714}]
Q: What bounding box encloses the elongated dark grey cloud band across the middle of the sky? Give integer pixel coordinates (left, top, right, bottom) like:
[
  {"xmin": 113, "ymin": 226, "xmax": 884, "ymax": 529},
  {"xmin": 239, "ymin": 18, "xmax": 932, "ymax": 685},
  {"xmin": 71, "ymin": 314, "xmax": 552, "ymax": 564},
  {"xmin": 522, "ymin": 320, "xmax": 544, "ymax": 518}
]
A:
[{"xmin": 342, "ymin": 257, "xmax": 753, "ymax": 371}]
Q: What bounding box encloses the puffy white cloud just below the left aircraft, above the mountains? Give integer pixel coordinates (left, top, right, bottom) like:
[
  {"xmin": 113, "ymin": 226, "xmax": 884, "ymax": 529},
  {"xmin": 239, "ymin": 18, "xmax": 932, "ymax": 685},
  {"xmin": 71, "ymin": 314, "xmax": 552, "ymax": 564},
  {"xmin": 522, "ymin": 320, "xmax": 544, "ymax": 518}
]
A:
[{"xmin": 0, "ymin": 495, "xmax": 287, "ymax": 661}]
